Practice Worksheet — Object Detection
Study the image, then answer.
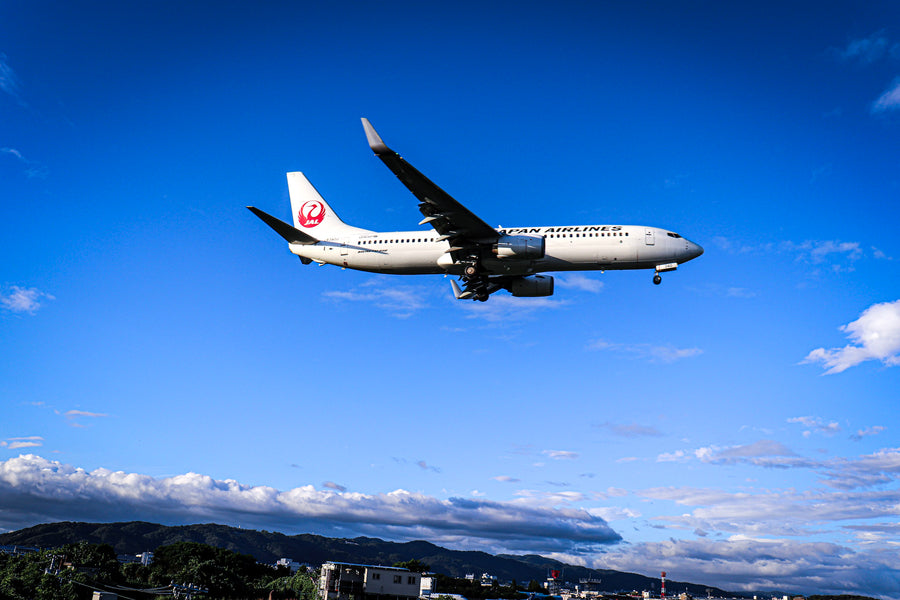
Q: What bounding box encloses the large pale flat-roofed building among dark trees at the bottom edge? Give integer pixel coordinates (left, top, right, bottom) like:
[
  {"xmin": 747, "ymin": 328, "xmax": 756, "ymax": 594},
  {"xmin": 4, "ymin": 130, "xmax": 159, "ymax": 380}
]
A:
[{"xmin": 318, "ymin": 562, "xmax": 422, "ymax": 600}]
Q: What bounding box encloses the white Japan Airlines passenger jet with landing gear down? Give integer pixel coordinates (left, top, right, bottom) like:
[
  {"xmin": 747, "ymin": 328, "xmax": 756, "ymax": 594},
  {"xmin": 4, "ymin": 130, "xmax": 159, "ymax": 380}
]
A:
[{"xmin": 247, "ymin": 118, "xmax": 703, "ymax": 302}]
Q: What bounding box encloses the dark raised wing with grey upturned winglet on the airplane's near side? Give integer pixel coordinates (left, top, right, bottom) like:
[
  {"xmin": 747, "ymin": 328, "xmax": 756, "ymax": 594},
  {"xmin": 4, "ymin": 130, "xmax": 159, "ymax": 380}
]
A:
[{"xmin": 362, "ymin": 119, "xmax": 500, "ymax": 250}]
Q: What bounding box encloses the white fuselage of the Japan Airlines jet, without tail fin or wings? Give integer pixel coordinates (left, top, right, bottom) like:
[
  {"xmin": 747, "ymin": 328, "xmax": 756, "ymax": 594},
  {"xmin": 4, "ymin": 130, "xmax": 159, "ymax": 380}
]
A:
[{"xmin": 290, "ymin": 225, "xmax": 703, "ymax": 275}]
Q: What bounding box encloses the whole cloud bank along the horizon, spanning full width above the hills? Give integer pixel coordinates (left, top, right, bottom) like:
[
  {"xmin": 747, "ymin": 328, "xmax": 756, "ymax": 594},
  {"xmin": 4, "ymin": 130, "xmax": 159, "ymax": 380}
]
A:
[{"xmin": 0, "ymin": 452, "xmax": 900, "ymax": 598}]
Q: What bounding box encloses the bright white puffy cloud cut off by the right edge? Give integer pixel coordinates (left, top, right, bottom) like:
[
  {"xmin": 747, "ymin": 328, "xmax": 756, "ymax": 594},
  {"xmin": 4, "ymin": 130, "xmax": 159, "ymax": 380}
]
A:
[{"xmin": 801, "ymin": 300, "xmax": 900, "ymax": 375}]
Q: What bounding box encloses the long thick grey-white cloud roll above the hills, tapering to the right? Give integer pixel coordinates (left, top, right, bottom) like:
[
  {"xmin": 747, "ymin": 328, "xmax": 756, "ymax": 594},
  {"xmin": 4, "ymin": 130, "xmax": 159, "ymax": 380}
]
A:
[{"xmin": 0, "ymin": 455, "xmax": 621, "ymax": 552}]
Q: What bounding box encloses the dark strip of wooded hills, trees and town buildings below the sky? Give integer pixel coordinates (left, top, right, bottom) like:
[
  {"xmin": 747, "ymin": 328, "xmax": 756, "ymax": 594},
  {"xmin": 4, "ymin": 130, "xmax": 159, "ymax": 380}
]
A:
[{"xmin": 0, "ymin": 521, "xmax": 880, "ymax": 600}]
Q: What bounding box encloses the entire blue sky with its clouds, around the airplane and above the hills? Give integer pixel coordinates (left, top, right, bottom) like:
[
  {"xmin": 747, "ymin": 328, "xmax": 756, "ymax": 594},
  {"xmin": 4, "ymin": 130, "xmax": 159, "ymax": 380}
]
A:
[{"xmin": 0, "ymin": 1, "xmax": 900, "ymax": 598}]
